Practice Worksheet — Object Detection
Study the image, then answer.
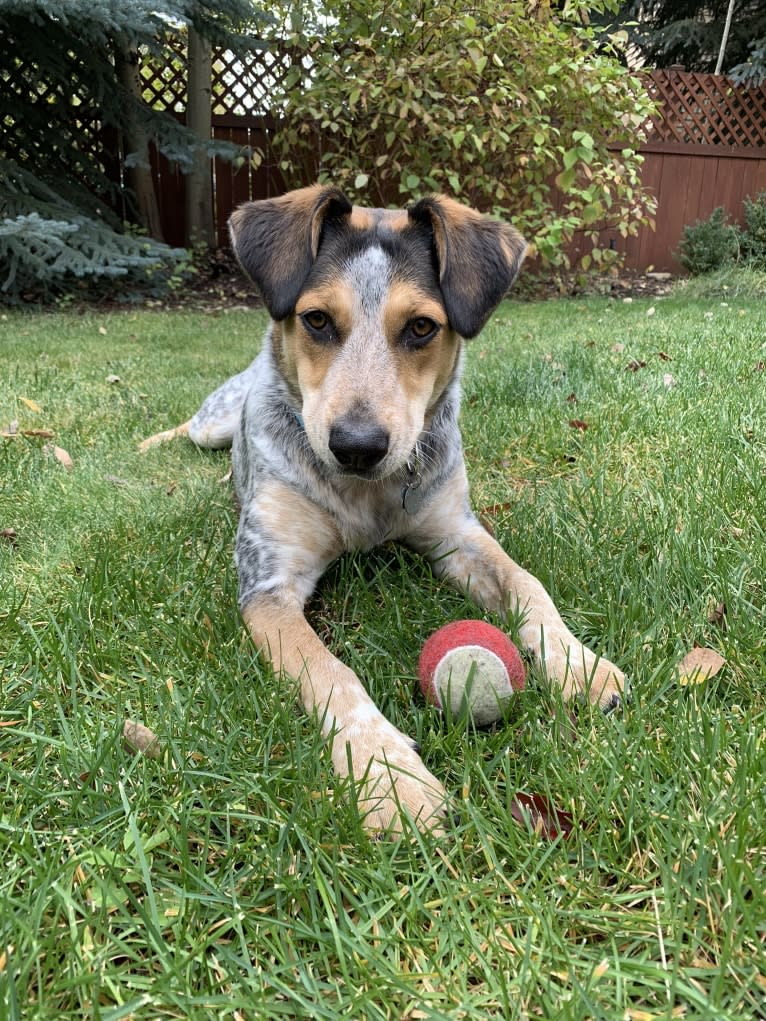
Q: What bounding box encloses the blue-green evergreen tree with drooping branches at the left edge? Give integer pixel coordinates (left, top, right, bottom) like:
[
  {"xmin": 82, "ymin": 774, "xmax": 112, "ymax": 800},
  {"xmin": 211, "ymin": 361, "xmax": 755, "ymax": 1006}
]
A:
[{"xmin": 0, "ymin": 0, "xmax": 267, "ymax": 300}]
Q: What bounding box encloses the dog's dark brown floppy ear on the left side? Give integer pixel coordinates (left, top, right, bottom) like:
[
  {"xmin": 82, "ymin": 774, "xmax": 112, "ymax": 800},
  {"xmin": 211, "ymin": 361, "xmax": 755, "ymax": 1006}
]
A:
[{"xmin": 229, "ymin": 185, "xmax": 351, "ymax": 320}]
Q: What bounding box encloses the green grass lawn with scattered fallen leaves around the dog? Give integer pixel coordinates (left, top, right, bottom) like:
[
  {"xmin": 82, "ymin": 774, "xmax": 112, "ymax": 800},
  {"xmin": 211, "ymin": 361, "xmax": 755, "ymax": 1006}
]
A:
[{"xmin": 0, "ymin": 298, "xmax": 766, "ymax": 1021}]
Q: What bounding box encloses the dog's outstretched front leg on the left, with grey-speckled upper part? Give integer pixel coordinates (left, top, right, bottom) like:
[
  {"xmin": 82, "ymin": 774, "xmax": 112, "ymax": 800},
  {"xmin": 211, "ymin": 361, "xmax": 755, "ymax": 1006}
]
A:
[{"xmin": 237, "ymin": 481, "xmax": 446, "ymax": 831}]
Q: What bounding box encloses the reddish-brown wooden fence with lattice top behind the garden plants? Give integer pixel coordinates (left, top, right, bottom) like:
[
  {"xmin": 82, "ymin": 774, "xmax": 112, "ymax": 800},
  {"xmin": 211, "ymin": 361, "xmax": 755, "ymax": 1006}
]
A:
[{"xmin": 137, "ymin": 53, "xmax": 766, "ymax": 272}]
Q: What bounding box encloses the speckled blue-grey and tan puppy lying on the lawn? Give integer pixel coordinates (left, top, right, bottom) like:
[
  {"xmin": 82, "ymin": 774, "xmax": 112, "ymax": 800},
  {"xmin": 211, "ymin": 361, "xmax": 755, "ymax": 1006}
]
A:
[{"xmin": 142, "ymin": 185, "xmax": 624, "ymax": 833}]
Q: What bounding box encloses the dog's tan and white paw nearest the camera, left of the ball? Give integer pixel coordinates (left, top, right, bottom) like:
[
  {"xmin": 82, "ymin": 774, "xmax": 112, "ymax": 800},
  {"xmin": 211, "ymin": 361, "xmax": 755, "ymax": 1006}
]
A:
[{"xmin": 333, "ymin": 717, "xmax": 447, "ymax": 835}]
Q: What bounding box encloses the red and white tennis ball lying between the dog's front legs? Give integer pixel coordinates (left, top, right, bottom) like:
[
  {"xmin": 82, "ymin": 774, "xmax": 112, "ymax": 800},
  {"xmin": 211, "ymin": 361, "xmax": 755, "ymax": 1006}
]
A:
[{"xmin": 418, "ymin": 621, "xmax": 525, "ymax": 727}]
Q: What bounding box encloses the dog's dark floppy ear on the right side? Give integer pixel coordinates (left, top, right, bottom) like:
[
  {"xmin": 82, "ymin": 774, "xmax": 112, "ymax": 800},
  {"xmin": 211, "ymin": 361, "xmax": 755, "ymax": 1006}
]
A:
[{"xmin": 408, "ymin": 195, "xmax": 527, "ymax": 338}]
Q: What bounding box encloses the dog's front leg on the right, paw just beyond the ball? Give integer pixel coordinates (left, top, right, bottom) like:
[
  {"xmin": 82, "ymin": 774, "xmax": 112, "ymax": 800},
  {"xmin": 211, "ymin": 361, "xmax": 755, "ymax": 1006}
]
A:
[{"xmin": 409, "ymin": 478, "xmax": 625, "ymax": 710}]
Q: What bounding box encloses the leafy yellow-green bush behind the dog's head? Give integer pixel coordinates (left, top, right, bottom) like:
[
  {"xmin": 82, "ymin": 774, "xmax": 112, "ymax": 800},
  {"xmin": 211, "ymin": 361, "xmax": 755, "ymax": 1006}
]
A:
[{"xmin": 275, "ymin": 0, "xmax": 651, "ymax": 265}]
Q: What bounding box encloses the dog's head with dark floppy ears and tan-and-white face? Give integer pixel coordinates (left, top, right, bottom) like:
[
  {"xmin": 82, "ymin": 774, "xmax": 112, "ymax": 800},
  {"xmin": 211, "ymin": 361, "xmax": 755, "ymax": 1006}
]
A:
[{"xmin": 230, "ymin": 185, "xmax": 525, "ymax": 479}]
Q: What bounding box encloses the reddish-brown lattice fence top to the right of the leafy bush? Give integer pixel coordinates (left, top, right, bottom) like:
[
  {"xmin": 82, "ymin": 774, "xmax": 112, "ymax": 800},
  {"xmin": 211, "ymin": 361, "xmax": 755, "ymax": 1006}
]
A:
[{"xmin": 647, "ymin": 70, "xmax": 766, "ymax": 148}]
